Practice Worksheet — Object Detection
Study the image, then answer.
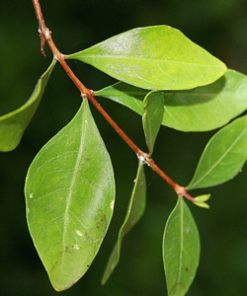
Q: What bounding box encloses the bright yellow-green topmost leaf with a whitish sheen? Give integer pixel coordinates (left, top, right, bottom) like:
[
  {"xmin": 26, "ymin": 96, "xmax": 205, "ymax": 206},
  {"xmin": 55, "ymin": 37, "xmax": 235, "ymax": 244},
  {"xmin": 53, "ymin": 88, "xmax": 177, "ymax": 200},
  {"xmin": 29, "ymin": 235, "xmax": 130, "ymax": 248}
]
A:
[{"xmin": 67, "ymin": 26, "xmax": 226, "ymax": 90}]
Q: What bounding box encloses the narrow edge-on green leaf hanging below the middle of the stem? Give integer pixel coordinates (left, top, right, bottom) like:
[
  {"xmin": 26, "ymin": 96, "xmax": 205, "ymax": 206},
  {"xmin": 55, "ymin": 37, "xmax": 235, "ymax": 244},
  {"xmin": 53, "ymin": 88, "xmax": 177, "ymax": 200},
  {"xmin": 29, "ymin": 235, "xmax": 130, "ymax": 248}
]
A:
[{"xmin": 102, "ymin": 162, "xmax": 146, "ymax": 284}]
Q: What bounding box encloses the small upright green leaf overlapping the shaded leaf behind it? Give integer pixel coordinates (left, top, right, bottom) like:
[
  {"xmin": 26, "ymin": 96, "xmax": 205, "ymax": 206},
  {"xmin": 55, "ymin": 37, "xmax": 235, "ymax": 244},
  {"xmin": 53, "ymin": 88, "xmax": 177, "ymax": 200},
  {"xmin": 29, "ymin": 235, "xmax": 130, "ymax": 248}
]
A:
[{"xmin": 142, "ymin": 92, "xmax": 164, "ymax": 155}]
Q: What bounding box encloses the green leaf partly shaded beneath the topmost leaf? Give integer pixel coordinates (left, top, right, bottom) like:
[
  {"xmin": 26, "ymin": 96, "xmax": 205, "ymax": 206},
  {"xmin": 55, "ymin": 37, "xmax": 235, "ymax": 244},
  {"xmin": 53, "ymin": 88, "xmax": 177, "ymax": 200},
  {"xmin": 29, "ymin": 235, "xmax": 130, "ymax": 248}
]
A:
[{"xmin": 96, "ymin": 70, "xmax": 247, "ymax": 132}]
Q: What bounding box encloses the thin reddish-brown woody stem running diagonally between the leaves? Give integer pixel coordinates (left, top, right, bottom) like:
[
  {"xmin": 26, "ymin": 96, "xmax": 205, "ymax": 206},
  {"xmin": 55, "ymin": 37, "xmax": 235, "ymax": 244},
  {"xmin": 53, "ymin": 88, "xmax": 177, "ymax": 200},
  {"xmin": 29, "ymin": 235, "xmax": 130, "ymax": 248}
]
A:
[{"xmin": 32, "ymin": 0, "xmax": 194, "ymax": 201}]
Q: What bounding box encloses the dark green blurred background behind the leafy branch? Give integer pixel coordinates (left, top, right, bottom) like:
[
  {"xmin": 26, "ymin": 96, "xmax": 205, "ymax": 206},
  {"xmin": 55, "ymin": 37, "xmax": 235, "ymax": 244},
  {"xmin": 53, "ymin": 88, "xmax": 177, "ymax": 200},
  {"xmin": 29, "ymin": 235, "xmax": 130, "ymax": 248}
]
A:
[{"xmin": 0, "ymin": 0, "xmax": 247, "ymax": 296}]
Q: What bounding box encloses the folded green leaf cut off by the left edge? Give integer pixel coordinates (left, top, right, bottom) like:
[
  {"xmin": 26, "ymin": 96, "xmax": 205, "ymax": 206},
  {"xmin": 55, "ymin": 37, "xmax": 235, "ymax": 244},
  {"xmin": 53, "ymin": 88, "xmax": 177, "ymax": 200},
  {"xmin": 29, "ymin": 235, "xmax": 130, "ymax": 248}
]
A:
[{"xmin": 0, "ymin": 60, "xmax": 56, "ymax": 152}]
